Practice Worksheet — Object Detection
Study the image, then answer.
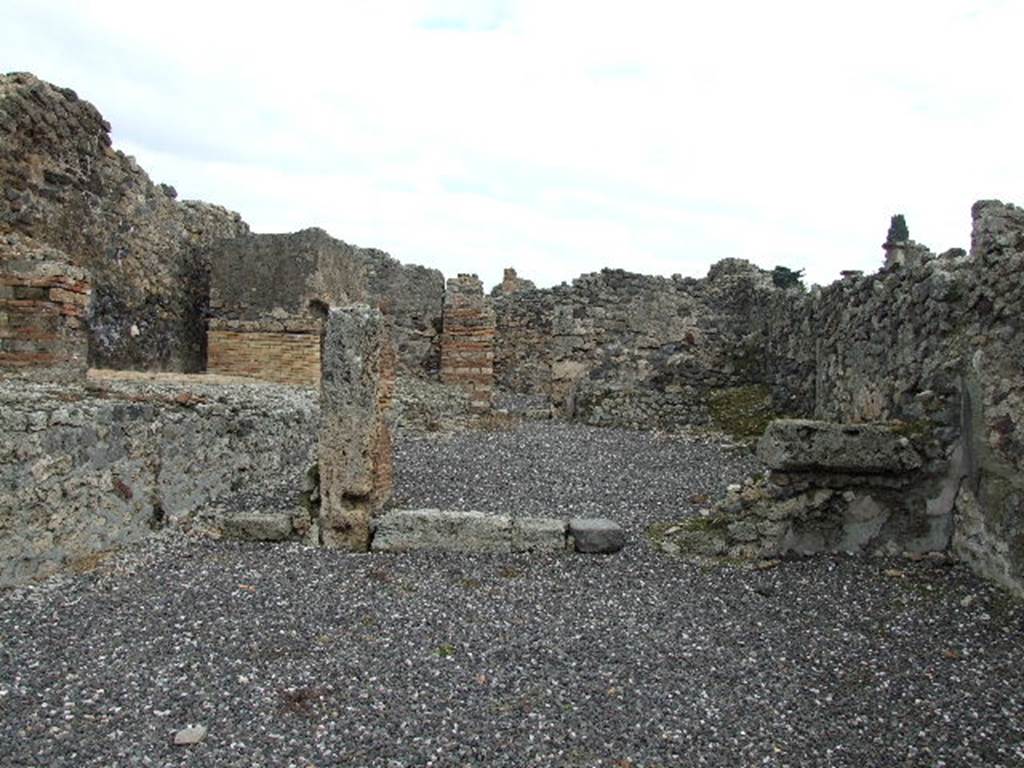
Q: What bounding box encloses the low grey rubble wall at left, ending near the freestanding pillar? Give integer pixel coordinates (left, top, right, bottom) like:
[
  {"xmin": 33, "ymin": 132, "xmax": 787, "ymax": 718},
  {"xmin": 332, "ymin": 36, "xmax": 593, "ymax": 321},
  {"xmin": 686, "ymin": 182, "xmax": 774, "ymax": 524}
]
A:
[{"xmin": 0, "ymin": 377, "xmax": 319, "ymax": 586}]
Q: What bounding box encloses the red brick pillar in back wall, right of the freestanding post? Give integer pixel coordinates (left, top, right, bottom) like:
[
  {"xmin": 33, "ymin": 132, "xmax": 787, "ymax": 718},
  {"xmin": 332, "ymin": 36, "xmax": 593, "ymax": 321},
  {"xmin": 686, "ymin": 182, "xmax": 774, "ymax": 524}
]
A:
[{"xmin": 440, "ymin": 274, "xmax": 495, "ymax": 412}]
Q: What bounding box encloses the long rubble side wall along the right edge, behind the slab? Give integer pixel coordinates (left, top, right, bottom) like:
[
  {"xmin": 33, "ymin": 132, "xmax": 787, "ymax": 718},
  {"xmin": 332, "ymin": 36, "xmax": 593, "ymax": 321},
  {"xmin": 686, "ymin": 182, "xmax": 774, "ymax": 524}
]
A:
[{"xmin": 769, "ymin": 201, "xmax": 1024, "ymax": 589}]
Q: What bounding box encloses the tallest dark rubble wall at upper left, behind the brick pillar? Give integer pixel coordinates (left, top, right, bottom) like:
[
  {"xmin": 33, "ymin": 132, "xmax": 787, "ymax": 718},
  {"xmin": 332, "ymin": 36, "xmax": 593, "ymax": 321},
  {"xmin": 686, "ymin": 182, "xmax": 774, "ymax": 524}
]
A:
[{"xmin": 0, "ymin": 74, "xmax": 248, "ymax": 371}]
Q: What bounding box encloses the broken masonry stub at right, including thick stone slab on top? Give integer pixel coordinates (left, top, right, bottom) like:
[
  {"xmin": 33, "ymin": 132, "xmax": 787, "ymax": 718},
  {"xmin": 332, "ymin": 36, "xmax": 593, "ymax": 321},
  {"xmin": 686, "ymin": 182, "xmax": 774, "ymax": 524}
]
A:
[{"xmin": 658, "ymin": 420, "xmax": 959, "ymax": 558}]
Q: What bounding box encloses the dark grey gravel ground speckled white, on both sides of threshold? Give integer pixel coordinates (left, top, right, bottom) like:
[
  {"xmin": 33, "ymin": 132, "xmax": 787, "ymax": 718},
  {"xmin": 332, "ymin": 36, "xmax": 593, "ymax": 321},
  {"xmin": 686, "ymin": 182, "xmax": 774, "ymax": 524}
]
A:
[{"xmin": 0, "ymin": 425, "xmax": 1024, "ymax": 768}]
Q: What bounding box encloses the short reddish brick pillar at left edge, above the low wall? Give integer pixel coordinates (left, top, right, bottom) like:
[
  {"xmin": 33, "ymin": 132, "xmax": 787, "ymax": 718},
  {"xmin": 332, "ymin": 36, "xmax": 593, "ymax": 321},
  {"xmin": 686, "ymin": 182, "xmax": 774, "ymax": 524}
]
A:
[{"xmin": 0, "ymin": 253, "xmax": 92, "ymax": 381}]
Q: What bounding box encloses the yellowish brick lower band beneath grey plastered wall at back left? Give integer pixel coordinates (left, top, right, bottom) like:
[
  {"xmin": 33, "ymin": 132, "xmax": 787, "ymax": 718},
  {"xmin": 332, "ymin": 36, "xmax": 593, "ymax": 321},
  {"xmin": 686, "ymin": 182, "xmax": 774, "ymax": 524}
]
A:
[{"xmin": 206, "ymin": 322, "xmax": 321, "ymax": 386}]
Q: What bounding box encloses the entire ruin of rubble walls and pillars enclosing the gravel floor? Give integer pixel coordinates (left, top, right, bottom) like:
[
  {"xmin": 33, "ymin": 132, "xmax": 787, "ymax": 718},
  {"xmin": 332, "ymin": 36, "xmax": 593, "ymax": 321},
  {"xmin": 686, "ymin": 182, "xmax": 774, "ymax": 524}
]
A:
[{"xmin": 0, "ymin": 74, "xmax": 1024, "ymax": 606}]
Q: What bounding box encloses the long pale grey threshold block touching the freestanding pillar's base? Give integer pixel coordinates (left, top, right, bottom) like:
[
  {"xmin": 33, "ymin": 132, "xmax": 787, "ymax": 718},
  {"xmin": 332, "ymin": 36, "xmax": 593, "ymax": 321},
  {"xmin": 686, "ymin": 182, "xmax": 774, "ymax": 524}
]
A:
[{"xmin": 371, "ymin": 509, "xmax": 512, "ymax": 552}]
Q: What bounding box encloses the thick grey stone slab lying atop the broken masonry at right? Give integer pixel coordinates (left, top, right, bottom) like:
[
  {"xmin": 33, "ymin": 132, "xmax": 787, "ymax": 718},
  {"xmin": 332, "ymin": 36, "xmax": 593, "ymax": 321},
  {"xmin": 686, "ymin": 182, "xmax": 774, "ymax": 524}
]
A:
[{"xmin": 758, "ymin": 419, "xmax": 922, "ymax": 474}]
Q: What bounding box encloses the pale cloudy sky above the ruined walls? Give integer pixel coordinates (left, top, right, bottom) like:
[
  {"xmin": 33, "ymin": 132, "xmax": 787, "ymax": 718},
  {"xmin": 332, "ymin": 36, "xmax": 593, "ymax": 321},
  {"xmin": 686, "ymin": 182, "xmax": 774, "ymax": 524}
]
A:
[{"xmin": 0, "ymin": 0, "xmax": 1024, "ymax": 286}]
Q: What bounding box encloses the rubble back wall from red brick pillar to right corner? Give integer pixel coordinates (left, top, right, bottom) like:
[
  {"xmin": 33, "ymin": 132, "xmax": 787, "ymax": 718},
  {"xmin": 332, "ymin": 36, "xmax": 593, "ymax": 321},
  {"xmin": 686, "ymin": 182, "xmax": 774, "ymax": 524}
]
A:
[{"xmin": 495, "ymin": 260, "xmax": 782, "ymax": 428}]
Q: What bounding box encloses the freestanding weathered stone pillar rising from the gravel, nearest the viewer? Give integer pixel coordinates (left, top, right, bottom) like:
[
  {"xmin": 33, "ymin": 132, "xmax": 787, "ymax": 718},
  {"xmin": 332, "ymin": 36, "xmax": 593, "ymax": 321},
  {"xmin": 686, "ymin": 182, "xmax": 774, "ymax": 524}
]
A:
[{"xmin": 317, "ymin": 304, "xmax": 395, "ymax": 552}]
